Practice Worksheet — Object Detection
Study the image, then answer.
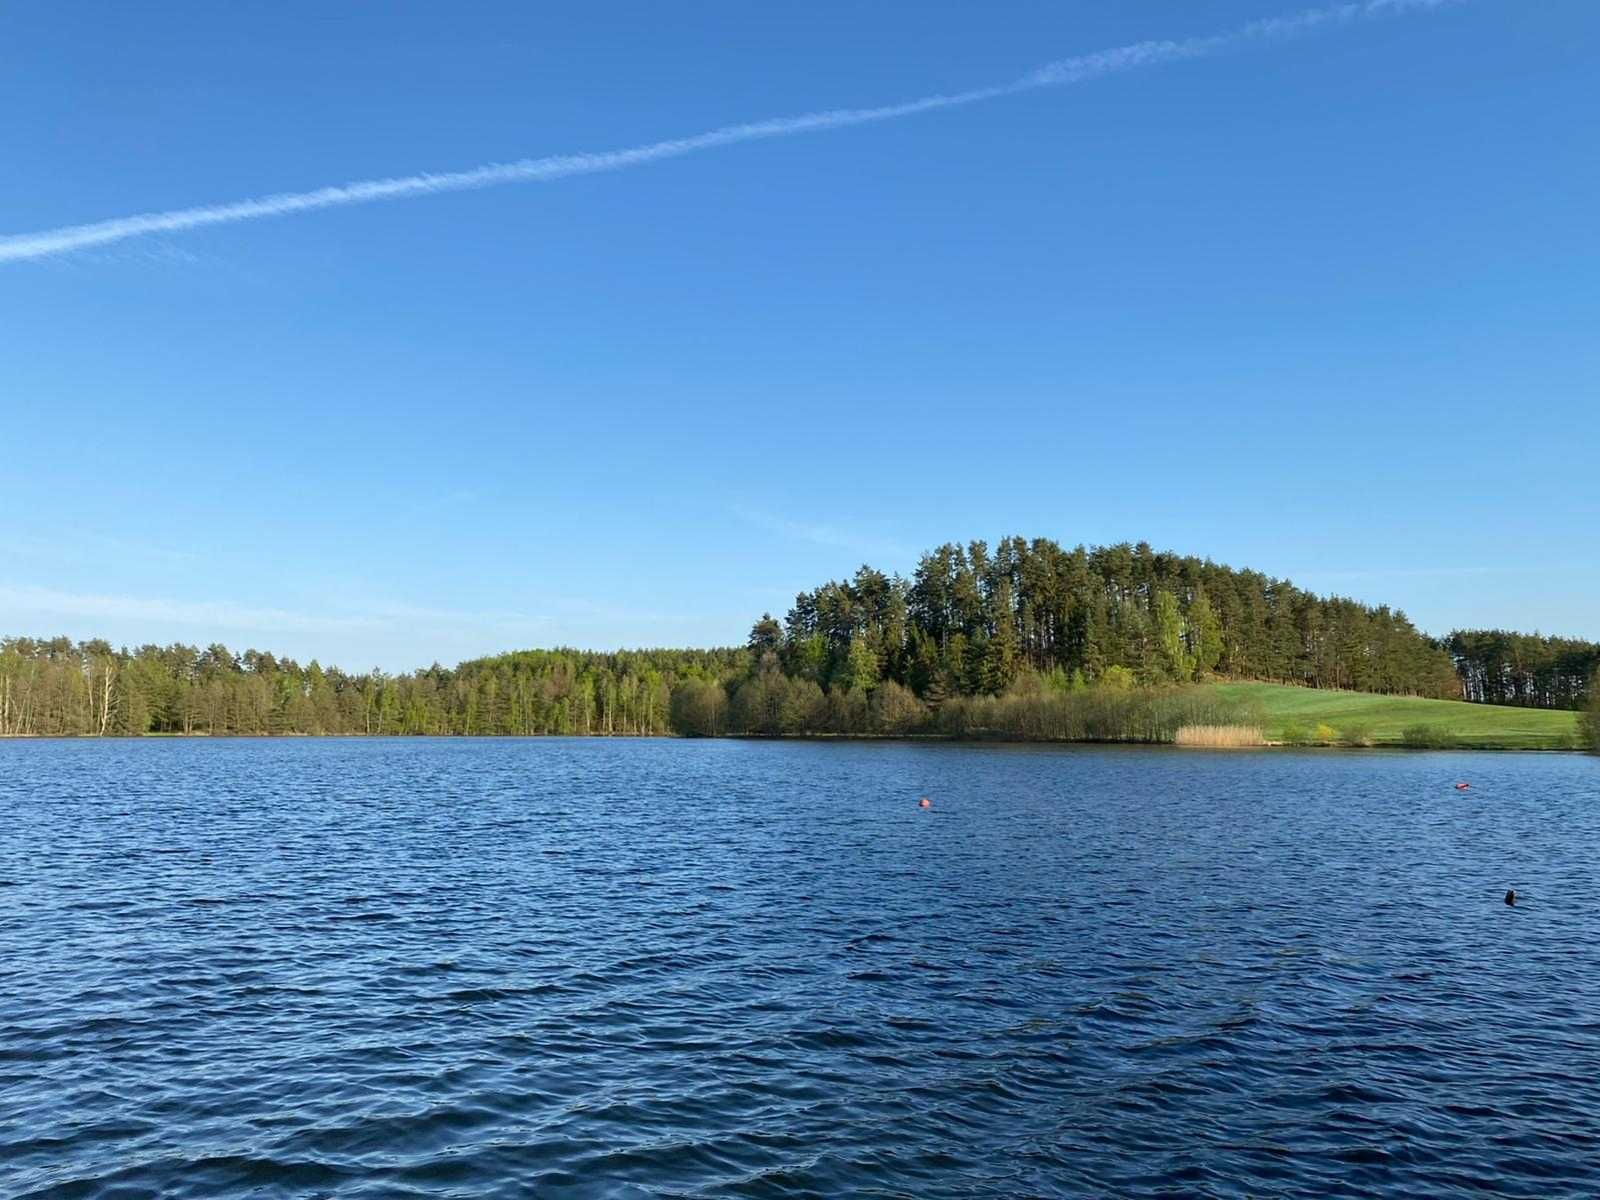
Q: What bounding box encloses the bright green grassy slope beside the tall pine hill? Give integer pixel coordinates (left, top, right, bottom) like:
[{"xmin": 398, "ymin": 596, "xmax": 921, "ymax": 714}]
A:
[{"xmin": 1216, "ymin": 683, "xmax": 1578, "ymax": 750}]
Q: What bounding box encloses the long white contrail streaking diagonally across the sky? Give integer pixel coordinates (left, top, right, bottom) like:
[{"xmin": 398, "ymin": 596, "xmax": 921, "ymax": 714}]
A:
[{"xmin": 0, "ymin": 0, "xmax": 1461, "ymax": 262}]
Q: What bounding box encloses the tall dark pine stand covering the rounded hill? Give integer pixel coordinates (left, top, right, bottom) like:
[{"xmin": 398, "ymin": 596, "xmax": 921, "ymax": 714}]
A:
[{"xmin": 763, "ymin": 538, "xmax": 1459, "ymax": 699}]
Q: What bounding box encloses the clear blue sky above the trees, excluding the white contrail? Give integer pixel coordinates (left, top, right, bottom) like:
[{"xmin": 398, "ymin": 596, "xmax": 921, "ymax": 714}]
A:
[{"xmin": 0, "ymin": 0, "xmax": 1600, "ymax": 669}]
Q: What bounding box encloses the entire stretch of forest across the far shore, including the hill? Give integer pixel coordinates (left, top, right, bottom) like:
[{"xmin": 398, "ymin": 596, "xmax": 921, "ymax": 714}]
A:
[{"xmin": 0, "ymin": 538, "xmax": 1600, "ymax": 741}]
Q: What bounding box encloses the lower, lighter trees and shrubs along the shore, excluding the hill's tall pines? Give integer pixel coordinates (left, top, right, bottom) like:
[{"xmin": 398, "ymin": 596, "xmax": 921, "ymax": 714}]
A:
[{"xmin": 0, "ymin": 638, "xmax": 1242, "ymax": 741}]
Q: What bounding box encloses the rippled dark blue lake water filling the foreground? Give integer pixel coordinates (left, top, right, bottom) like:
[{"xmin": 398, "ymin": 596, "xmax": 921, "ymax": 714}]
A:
[{"xmin": 0, "ymin": 741, "xmax": 1600, "ymax": 1200}]
